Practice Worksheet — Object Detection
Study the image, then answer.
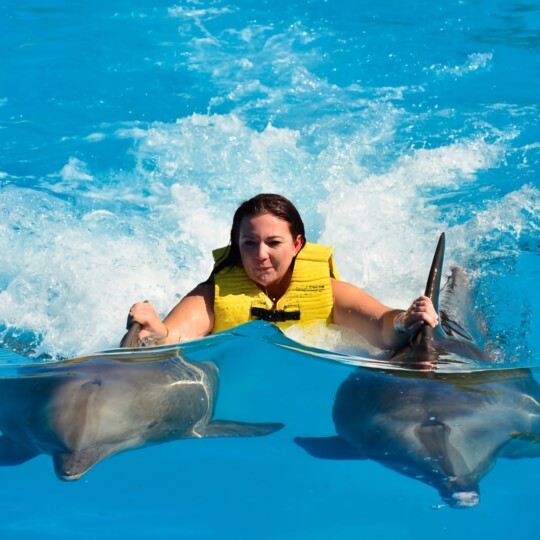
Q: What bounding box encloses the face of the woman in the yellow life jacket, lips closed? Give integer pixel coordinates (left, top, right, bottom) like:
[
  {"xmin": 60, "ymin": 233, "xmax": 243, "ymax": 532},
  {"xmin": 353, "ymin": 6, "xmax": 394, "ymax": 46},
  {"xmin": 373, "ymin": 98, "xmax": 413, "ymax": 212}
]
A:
[{"xmin": 238, "ymin": 214, "xmax": 302, "ymax": 294}]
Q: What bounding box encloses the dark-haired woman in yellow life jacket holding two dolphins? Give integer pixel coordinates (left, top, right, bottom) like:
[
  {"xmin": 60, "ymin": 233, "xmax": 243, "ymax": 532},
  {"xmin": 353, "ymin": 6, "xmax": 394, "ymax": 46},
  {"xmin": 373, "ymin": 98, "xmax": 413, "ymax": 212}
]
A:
[{"xmin": 130, "ymin": 194, "xmax": 438, "ymax": 349}]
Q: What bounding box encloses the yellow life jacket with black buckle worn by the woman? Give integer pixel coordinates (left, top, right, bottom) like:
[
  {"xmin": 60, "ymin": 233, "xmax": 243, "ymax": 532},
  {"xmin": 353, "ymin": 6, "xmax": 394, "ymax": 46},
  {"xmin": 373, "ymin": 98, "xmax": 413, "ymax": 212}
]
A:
[{"xmin": 212, "ymin": 243, "xmax": 339, "ymax": 333}]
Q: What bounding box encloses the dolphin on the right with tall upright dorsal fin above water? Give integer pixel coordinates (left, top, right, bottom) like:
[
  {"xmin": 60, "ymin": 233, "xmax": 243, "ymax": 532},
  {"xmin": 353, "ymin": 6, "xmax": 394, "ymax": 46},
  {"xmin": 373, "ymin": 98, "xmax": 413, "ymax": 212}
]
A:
[{"xmin": 295, "ymin": 236, "xmax": 540, "ymax": 508}]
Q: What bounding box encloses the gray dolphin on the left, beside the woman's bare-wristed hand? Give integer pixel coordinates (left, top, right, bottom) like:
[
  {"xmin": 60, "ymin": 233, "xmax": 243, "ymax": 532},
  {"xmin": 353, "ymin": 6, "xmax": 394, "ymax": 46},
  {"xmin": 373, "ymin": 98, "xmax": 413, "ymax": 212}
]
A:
[{"xmin": 0, "ymin": 344, "xmax": 283, "ymax": 480}]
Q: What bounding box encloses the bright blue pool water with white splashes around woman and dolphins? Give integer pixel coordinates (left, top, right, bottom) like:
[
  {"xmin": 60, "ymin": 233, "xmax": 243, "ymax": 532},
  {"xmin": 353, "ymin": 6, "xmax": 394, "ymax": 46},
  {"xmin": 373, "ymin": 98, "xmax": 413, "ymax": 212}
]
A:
[{"xmin": 0, "ymin": 0, "xmax": 540, "ymax": 539}]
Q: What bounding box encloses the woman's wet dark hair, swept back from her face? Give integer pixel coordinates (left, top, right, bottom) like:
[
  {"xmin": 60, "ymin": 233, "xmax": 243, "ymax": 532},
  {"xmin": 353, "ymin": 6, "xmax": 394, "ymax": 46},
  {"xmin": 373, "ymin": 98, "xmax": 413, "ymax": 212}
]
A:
[{"xmin": 210, "ymin": 193, "xmax": 306, "ymax": 279}]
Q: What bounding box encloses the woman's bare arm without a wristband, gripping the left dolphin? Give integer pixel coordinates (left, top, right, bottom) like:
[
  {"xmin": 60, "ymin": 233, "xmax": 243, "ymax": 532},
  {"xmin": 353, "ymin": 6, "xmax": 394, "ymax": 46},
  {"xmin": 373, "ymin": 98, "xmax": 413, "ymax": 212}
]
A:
[{"xmin": 129, "ymin": 282, "xmax": 214, "ymax": 345}]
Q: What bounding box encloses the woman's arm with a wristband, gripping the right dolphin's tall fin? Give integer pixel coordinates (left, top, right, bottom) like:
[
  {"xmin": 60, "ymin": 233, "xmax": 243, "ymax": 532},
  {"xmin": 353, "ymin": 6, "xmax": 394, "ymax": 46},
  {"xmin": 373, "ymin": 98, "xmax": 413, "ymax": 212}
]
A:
[{"xmin": 332, "ymin": 279, "xmax": 438, "ymax": 349}]
